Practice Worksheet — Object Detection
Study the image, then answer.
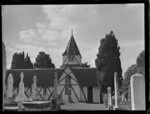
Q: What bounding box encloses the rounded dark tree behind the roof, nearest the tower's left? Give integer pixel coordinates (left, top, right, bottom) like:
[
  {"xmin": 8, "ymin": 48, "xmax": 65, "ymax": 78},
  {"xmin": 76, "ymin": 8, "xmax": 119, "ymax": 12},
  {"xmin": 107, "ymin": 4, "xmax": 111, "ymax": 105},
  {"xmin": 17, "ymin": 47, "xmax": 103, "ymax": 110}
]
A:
[{"xmin": 34, "ymin": 52, "xmax": 55, "ymax": 68}]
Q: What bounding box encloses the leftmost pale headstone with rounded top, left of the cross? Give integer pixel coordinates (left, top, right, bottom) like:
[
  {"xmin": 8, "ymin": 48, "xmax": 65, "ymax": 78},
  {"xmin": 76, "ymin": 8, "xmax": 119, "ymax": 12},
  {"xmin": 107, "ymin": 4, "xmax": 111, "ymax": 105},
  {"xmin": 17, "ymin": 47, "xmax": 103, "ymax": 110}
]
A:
[{"xmin": 7, "ymin": 73, "xmax": 13, "ymax": 98}]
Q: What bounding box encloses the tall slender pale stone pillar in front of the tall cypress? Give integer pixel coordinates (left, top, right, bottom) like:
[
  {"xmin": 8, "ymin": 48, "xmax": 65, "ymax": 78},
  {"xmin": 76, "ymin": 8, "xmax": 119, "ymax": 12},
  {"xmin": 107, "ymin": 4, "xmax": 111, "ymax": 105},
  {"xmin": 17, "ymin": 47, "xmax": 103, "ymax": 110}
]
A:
[{"xmin": 114, "ymin": 72, "xmax": 118, "ymax": 108}]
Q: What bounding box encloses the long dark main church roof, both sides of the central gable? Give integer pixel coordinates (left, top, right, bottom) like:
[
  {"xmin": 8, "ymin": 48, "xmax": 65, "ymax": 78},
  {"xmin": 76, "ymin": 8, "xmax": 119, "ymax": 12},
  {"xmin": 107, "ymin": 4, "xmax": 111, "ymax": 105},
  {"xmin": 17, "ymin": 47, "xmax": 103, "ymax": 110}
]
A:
[{"xmin": 5, "ymin": 67, "xmax": 97, "ymax": 88}]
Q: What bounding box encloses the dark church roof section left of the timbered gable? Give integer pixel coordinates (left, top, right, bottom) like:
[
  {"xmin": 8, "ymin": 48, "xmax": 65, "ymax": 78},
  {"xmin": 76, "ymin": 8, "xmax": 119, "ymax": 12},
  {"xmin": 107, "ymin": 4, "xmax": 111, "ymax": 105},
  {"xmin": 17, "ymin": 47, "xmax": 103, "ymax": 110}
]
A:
[{"xmin": 5, "ymin": 68, "xmax": 63, "ymax": 87}]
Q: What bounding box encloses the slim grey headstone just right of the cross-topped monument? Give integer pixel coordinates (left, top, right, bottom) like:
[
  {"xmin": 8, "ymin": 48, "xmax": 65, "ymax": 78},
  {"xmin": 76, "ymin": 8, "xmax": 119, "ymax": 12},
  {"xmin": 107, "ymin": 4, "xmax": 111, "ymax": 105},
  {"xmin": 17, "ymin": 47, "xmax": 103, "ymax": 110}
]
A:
[{"xmin": 31, "ymin": 76, "xmax": 37, "ymax": 100}]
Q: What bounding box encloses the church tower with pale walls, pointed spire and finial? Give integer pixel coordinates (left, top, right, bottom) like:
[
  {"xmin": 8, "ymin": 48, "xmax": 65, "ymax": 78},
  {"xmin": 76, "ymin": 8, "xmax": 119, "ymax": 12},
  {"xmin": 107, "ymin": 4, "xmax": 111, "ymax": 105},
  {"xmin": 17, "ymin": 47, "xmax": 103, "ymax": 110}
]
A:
[{"xmin": 61, "ymin": 30, "xmax": 82, "ymax": 67}]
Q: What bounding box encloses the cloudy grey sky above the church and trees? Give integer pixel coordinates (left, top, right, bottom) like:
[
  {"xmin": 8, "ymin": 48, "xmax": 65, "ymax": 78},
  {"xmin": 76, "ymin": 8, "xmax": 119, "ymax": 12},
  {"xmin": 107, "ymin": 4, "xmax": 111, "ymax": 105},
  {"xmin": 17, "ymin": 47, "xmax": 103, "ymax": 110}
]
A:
[{"xmin": 2, "ymin": 4, "xmax": 144, "ymax": 76}]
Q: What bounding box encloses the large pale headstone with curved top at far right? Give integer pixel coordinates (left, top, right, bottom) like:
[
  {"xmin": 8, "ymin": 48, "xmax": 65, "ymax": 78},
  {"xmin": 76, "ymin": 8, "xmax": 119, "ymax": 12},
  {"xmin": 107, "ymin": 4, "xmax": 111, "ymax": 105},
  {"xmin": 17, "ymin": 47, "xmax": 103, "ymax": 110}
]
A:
[{"xmin": 130, "ymin": 73, "xmax": 146, "ymax": 110}]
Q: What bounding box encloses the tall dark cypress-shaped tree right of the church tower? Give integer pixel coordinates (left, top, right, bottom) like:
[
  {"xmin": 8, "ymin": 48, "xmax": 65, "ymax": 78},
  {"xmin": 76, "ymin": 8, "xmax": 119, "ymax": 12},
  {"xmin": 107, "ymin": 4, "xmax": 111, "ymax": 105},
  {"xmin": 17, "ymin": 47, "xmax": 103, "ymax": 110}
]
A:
[{"xmin": 95, "ymin": 31, "xmax": 123, "ymax": 102}]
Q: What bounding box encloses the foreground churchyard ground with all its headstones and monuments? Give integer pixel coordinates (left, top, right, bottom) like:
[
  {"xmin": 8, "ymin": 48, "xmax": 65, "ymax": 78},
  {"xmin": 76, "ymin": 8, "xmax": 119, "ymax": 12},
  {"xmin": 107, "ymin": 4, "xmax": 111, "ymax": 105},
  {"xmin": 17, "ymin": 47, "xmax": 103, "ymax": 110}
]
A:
[{"xmin": 4, "ymin": 73, "xmax": 145, "ymax": 111}]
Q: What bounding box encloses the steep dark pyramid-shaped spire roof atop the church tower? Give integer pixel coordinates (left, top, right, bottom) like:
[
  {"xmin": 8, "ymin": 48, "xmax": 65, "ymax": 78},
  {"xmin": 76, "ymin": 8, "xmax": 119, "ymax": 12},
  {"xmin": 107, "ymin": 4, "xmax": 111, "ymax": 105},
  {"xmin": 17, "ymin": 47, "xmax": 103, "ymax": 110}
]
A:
[{"xmin": 62, "ymin": 33, "xmax": 81, "ymax": 56}]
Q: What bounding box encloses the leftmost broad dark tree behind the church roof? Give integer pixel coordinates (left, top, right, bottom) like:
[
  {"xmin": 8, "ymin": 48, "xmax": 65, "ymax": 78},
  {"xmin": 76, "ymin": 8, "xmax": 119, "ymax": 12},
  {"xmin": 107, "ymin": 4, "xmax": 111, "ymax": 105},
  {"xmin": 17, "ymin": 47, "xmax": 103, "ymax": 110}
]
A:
[{"xmin": 11, "ymin": 52, "xmax": 24, "ymax": 69}]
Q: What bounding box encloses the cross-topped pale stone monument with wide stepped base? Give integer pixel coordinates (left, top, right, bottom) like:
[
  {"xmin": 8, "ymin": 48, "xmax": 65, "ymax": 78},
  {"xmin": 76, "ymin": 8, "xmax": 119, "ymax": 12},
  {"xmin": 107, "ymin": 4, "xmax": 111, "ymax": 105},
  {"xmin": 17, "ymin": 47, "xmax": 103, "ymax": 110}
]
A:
[{"xmin": 15, "ymin": 72, "xmax": 28, "ymax": 102}]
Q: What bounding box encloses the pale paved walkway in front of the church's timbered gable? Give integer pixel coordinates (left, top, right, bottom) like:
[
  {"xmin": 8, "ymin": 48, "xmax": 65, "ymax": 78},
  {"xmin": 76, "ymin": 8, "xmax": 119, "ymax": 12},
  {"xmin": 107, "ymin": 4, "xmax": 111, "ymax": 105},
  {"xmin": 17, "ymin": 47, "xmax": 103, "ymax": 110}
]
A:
[{"xmin": 61, "ymin": 103, "xmax": 106, "ymax": 110}]
